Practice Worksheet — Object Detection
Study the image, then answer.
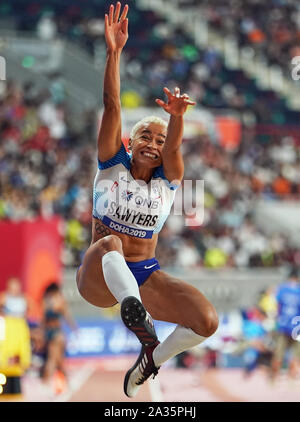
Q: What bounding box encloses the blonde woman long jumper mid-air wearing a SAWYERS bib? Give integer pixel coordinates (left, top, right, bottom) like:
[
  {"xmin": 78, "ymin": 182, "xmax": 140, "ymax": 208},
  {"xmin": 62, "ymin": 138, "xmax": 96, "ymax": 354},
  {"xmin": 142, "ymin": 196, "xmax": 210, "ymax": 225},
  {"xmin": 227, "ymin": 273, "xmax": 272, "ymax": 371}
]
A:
[{"xmin": 76, "ymin": 2, "xmax": 218, "ymax": 397}]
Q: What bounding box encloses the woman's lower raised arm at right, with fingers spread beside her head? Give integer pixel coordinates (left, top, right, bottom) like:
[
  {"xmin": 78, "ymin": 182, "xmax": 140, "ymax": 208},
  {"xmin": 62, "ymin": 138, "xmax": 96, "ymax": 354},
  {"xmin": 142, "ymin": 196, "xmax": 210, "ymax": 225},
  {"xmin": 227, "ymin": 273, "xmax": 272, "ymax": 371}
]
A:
[{"xmin": 156, "ymin": 87, "xmax": 196, "ymax": 182}]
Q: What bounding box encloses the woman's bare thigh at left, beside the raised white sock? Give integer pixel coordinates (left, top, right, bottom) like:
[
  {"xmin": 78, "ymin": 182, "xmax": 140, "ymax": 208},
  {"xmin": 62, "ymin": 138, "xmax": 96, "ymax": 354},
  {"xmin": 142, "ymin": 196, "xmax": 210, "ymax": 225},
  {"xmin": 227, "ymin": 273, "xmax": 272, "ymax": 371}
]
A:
[{"xmin": 76, "ymin": 242, "xmax": 117, "ymax": 308}]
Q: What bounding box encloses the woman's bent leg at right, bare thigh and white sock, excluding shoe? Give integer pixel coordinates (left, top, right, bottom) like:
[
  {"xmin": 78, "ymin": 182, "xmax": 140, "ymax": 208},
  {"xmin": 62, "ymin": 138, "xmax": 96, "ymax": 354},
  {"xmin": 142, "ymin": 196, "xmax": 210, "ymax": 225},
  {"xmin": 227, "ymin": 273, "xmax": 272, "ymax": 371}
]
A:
[{"xmin": 141, "ymin": 271, "xmax": 218, "ymax": 367}]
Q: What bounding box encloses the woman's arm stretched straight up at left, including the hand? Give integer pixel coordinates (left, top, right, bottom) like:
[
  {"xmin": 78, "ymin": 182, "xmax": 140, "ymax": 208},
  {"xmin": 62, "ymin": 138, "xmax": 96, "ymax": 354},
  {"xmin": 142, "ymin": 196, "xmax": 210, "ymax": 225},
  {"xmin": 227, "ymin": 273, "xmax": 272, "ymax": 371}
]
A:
[{"xmin": 98, "ymin": 2, "xmax": 128, "ymax": 161}]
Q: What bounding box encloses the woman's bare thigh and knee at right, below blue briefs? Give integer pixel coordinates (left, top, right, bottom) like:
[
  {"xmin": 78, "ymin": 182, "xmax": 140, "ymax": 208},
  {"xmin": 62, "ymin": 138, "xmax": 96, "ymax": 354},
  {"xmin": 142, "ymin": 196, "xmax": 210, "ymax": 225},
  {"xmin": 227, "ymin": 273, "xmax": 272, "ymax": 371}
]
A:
[{"xmin": 140, "ymin": 270, "xmax": 218, "ymax": 336}]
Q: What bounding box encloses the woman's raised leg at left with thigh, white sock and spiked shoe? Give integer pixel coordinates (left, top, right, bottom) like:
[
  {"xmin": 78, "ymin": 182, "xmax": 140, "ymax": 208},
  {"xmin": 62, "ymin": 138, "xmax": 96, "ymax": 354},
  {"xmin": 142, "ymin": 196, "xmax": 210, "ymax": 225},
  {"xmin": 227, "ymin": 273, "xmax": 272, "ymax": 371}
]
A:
[{"xmin": 77, "ymin": 235, "xmax": 157, "ymax": 345}]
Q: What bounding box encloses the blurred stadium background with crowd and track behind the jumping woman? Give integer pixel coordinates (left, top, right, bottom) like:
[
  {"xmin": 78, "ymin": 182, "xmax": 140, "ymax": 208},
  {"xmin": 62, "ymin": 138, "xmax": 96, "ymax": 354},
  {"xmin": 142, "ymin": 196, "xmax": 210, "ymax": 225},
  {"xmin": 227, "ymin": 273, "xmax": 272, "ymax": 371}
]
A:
[{"xmin": 0, "ymin": 0, "xmax": 300, "ymax": 402}]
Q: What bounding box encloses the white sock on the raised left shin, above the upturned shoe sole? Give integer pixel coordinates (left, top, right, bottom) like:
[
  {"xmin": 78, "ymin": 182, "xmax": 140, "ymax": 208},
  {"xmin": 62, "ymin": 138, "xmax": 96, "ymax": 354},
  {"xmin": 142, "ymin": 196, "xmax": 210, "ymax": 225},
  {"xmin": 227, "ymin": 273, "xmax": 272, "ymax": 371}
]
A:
[{"xmin": 102, "ymin": 251, "xmax": 142, "ymax": 303}]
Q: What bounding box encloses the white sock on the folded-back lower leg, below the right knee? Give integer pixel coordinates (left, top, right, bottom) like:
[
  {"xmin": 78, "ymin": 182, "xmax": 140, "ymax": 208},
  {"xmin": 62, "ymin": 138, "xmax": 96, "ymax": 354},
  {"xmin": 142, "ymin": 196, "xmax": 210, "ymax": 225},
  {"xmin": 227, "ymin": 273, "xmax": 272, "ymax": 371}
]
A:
[{"xmin": 153, "ymin": 325, "xmax": 207, "ymax": 368}]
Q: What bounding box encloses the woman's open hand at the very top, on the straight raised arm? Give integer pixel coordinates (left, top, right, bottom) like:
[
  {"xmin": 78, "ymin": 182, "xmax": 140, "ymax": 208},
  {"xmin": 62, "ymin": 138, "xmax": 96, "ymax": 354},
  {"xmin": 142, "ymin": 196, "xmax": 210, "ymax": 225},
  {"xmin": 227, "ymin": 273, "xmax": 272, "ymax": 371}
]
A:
[{"xmin": 105, "ymin": 2, "xmax": 128, "ymax": 51}]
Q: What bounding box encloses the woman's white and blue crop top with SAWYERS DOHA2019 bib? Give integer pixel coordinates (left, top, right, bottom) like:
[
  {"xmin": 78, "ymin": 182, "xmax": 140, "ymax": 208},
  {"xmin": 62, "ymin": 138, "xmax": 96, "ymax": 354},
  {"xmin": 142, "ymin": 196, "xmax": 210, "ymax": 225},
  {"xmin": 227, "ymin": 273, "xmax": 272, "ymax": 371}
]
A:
[{"xmin": 93, "ymin": 144, "xmax": 178, "ymax": 239}]
